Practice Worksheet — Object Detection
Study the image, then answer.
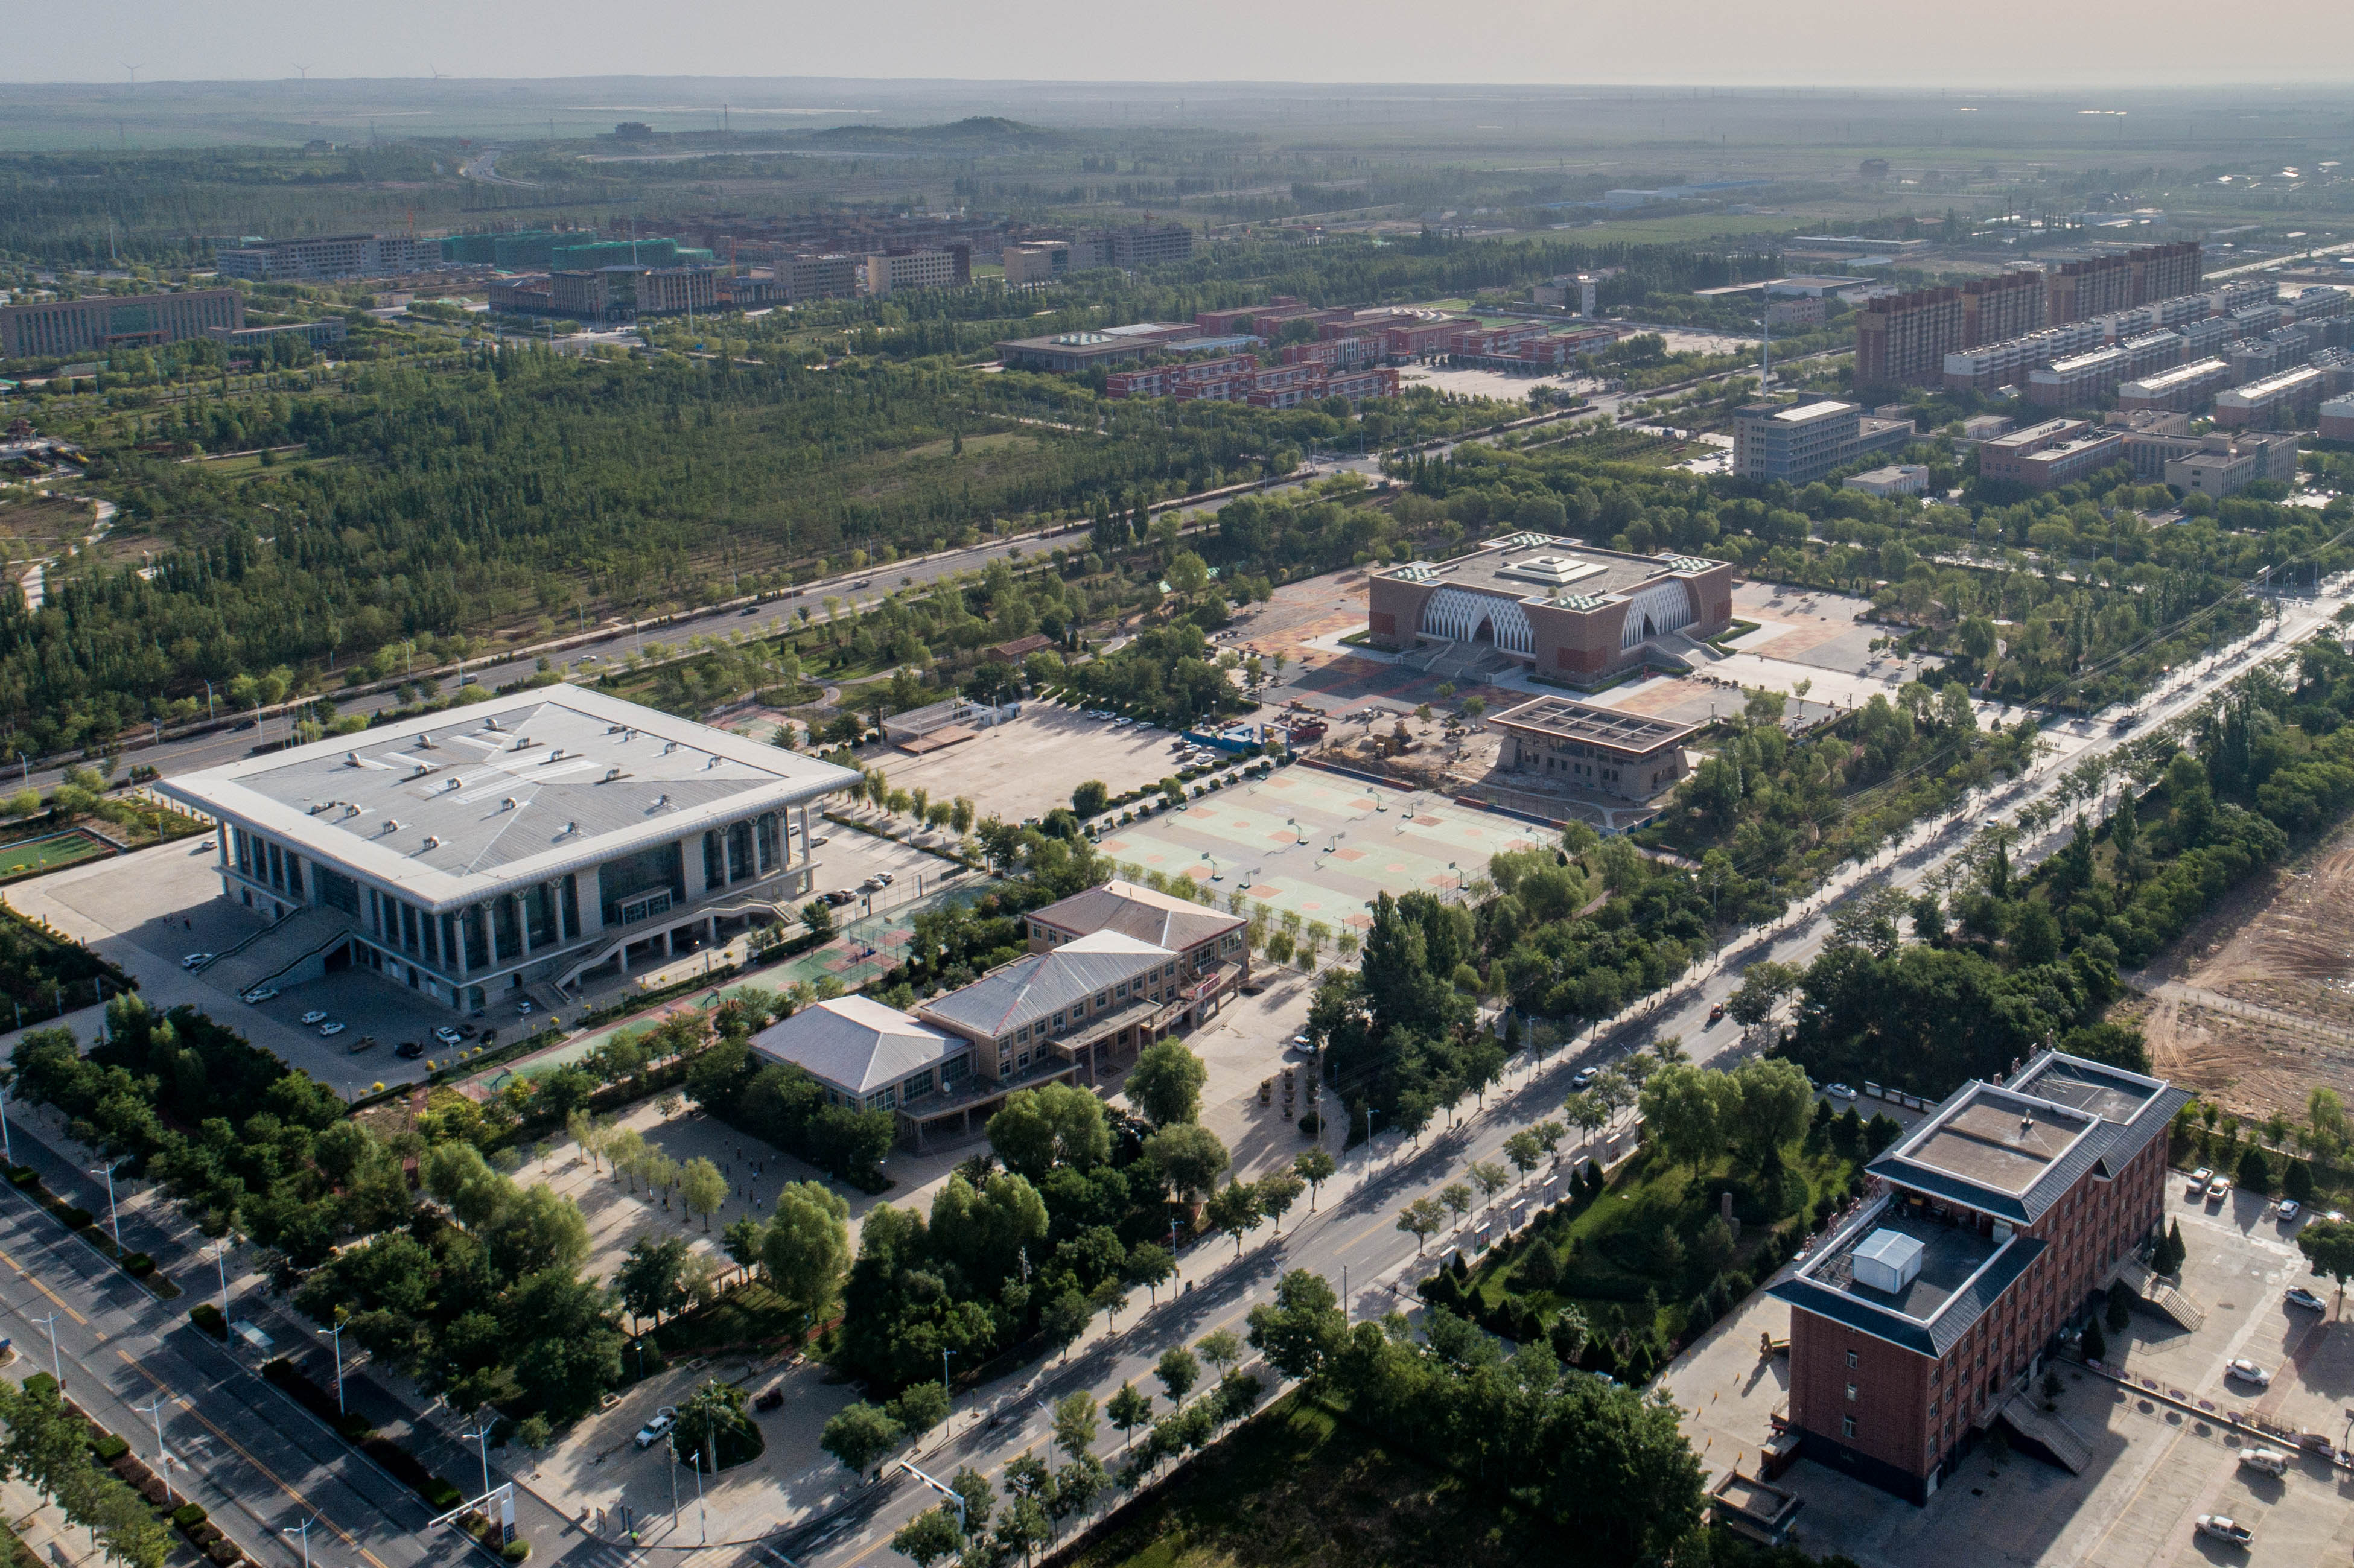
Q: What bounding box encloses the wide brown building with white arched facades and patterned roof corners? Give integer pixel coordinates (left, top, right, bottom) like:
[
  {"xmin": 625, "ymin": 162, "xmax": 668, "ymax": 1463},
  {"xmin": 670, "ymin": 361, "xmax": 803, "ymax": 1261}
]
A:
[{"xmin": 1366, "ymin": 535, "xmax": 1732, "ymax": 678}]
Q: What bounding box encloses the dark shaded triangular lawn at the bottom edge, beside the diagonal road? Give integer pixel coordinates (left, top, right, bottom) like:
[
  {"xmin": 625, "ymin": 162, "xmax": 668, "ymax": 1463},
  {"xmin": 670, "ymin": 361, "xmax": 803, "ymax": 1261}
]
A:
[{"xmin": 1052, "ymin": 1394, "xmax": 1577, "ymax": 1568}]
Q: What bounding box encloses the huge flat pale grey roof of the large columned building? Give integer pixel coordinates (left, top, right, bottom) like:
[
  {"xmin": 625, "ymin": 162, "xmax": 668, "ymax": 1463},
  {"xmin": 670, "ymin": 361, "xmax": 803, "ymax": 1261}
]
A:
[{"xmin": 157, "ymin": 685, "xmax": 859, "ymax": 909}]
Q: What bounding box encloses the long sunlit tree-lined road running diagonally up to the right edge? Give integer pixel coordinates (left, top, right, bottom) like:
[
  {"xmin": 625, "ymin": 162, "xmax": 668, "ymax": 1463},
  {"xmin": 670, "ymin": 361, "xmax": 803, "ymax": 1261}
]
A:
[{"xmin": 784, "ymin": 586, "xmax": 2342, "ymax": 1568}]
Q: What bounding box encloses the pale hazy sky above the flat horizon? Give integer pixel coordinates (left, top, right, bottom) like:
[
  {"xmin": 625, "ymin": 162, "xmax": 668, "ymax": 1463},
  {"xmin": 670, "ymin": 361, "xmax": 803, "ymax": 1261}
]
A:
[{"xmin": 27, "ymin": 0, "xmax": 2354, "ymax": 87}]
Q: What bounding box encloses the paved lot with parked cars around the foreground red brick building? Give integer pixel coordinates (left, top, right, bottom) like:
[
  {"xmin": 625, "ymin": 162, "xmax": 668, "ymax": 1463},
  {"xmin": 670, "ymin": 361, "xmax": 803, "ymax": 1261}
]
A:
[{"xmin": 1662, "ymin": 1154, "xmax": 2354, "ymax": 1568}]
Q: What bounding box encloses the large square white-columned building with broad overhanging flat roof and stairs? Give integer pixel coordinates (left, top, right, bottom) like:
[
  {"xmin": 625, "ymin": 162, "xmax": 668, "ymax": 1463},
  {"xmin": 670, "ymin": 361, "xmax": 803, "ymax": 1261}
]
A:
[{"xmin": 157, "ymin": 685, "xmax": 859, "ymax": 1010}]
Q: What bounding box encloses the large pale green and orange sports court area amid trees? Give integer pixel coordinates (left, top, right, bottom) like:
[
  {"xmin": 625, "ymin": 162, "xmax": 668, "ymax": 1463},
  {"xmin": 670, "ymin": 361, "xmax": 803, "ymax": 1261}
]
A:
[{"xmin": 1099, "ymin": 765, "xmax": 1558, "ymax": 930}]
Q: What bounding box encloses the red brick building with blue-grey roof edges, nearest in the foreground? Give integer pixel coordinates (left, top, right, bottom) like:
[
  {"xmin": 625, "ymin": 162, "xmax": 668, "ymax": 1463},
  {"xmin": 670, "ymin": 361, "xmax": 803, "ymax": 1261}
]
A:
[{"xmin": 1772, "ymin": 1050, "xmax": 2189, "ymax": 1502}]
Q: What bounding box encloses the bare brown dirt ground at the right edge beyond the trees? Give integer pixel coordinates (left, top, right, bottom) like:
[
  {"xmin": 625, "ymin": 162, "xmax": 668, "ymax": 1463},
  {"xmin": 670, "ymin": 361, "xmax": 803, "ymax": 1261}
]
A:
[{"xmin": 2116, "ymin": 824, "xmax": 2354, "ymax": 1116}]
